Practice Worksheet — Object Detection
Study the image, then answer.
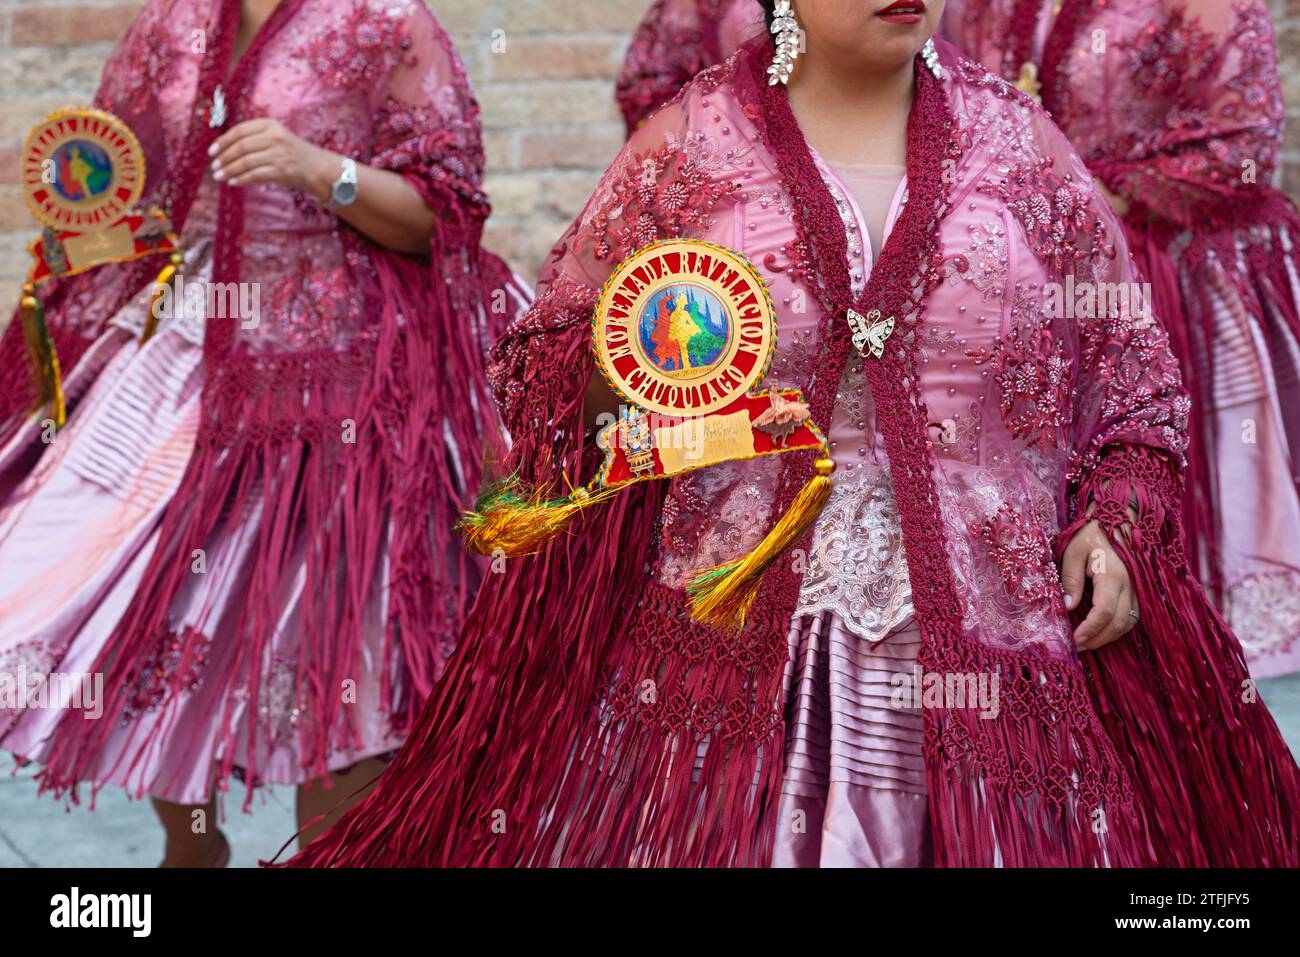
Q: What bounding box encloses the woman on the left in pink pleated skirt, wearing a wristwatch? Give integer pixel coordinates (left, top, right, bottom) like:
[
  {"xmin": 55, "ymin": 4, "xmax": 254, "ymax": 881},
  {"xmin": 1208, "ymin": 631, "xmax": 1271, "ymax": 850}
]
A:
[{"xmin": 0, "ymin": 0, "xmax": 517, "ymax": 865}]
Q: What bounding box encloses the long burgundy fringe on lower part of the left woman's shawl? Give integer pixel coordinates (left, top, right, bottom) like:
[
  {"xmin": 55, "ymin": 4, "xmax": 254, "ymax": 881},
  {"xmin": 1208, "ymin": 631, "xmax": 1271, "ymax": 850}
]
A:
[{"xmin": 34, "ymin": 227, "xmax": 501, "ymax": 804}]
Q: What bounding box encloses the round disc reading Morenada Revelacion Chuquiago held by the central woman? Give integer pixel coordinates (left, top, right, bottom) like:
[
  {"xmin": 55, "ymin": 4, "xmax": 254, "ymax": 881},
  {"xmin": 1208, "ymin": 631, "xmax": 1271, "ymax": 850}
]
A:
[{"xmin": 594, "ymin": 239, "xmax": 776, "ymax": 416}]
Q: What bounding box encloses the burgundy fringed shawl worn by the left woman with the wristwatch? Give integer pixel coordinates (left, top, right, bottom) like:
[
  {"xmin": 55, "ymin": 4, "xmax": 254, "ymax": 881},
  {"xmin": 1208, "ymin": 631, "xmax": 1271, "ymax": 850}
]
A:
[{"xmin": 0, "ymin": 0, "xmax": 511, "ymax": 794}]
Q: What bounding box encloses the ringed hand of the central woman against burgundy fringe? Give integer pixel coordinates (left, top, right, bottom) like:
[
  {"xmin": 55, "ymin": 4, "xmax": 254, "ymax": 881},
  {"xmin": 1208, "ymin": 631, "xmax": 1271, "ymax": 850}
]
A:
[{"xmin": 1061, "ymin": 520, "xmax": 1138, "ymax": 651}]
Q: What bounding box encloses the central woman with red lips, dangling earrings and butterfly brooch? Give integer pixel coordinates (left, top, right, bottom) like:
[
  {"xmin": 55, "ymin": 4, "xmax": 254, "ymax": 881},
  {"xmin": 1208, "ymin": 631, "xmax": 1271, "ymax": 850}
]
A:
[{"xmin": 287, "ymin": 0, "xmax": 1300, "ymax": 866}]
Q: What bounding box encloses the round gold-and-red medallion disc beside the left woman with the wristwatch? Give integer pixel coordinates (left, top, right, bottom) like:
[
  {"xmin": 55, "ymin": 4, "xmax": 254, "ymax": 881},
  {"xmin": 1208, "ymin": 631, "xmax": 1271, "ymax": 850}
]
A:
[{"xmin": 22, "ymin": 109, "xmax": 144, "ymax": 233}]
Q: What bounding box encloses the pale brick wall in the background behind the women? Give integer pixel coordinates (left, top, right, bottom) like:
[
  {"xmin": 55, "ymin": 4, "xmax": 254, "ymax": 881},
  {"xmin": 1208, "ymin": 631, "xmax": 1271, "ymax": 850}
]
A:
[{"xmin": 0, "ymin": 0, "xmax": 1300, "ymax": 312}]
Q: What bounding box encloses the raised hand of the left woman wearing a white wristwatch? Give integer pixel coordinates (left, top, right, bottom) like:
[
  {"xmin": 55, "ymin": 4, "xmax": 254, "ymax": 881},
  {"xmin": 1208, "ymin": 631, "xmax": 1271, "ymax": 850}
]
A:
[{"xmin": 208, "ymin": 118, "xmax": 342, "ymax": 203}]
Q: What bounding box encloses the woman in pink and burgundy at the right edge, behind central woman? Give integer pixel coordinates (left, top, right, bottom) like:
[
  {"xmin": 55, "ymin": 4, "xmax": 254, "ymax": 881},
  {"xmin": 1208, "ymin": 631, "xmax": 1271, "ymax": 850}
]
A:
[{"xmin": 944, "ymin": 0, "xmax": 1300, "ymax": 677}]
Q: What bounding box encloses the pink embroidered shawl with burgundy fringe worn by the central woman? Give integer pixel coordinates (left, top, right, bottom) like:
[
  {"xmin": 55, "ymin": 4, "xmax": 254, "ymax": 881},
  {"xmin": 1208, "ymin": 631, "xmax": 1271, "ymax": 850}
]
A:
[{"xmin": 287, "ymin": 39, "xmax": 1300, "ymax": 866}]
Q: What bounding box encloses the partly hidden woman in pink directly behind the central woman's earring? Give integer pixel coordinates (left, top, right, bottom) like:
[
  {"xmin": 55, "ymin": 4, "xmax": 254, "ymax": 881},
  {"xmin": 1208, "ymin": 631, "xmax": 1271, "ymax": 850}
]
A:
[{"xmin": 615, "ymin": 0, "xmax": 766, "ymax": 135}]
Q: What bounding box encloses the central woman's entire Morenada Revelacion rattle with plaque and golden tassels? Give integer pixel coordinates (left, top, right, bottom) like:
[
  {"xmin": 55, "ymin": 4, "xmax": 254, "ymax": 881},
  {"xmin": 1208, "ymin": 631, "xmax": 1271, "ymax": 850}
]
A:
[{"xmin": 460, "ymin": 239, "xmax": 835, "ymax": 631}]
